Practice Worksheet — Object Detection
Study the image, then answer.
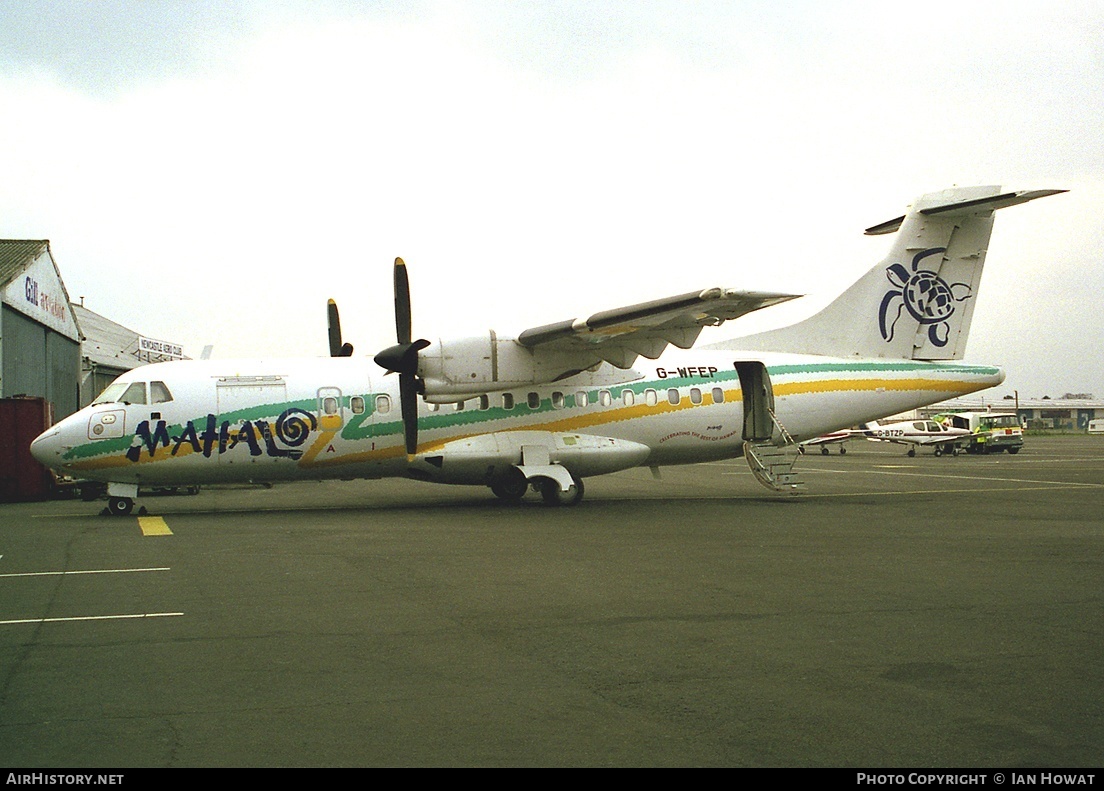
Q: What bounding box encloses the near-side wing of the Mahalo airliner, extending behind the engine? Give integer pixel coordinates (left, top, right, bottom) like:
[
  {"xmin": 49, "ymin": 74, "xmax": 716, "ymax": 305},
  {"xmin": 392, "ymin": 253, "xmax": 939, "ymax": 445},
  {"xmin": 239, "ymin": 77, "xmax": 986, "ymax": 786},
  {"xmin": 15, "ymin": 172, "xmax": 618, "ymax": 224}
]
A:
[{"xmin": 518, "ymin": 288, "xmax": 800, "ymax": 368}]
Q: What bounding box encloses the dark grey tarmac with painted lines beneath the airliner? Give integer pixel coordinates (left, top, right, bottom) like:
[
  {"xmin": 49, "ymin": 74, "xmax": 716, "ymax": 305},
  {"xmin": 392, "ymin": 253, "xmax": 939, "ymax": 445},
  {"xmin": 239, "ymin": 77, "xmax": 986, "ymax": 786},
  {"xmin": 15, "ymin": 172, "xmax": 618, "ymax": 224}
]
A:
[{"xmin": 0, "ymin": 435, "xmax": 1104, "ymax": 769}]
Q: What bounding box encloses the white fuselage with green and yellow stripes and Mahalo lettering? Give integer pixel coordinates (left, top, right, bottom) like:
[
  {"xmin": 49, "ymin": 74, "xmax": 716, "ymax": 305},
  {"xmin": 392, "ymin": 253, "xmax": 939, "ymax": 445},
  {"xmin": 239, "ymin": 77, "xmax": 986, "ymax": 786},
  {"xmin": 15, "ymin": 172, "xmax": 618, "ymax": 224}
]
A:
[{"xmin": 32, "ymin": 349, "xmax": 1004, "ymax": 485}]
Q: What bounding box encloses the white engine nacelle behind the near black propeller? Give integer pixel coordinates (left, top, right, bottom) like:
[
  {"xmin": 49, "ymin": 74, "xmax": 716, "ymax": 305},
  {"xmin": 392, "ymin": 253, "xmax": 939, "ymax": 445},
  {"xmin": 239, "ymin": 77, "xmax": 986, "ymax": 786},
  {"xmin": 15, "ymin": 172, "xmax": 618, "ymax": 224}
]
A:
[{"xmin": 417, "ymin": 330, "xmax": 604, "ymax": 403}]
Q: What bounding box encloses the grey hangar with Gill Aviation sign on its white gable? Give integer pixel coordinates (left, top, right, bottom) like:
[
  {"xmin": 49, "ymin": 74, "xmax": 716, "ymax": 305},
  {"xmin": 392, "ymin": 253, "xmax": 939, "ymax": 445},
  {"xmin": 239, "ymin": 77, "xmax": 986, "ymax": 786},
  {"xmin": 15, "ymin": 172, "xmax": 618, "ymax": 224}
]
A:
[{"xmin": 0, "ymin": 239, "xmax": 81, "ymax": 420}]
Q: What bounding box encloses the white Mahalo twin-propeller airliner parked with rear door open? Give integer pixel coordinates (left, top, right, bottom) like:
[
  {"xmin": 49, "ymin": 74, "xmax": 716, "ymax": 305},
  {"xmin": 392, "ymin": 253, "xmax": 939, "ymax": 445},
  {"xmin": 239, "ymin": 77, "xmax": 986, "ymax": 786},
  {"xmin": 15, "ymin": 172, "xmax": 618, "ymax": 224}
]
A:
[{"xmin": 31, "ymin": 187, "xmax": 1064, "ymax": 515}]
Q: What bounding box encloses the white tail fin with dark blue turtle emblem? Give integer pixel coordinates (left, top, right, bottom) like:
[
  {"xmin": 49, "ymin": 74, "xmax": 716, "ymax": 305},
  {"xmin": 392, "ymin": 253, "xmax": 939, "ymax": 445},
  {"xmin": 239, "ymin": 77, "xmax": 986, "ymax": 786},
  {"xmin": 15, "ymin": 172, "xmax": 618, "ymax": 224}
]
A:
[{"xmin": 718, "ymin": 187, "xmax": 1065, "ymax": 360}]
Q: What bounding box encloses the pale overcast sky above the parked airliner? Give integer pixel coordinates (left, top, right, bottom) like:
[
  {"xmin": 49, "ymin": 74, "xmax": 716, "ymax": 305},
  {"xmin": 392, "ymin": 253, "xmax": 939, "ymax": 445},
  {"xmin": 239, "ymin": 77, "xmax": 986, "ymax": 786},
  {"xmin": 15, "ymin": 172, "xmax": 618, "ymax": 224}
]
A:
[{"xmin": 0, "ymin": 0, "xmax": 1104, "ymax": 398}]
